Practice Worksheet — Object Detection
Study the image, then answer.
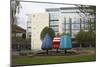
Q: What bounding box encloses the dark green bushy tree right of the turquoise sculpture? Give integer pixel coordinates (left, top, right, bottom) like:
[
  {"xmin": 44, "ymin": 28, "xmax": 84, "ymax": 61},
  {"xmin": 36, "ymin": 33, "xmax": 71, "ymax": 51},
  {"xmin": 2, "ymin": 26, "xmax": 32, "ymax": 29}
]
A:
[{"xmin": 75, "ymin": 31, "xmax": 96, "ymax": 46}]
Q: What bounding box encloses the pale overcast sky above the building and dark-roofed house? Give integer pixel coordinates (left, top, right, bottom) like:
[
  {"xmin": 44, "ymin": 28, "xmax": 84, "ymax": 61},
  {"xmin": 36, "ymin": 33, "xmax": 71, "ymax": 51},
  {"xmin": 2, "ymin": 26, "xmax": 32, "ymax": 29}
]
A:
[{"xmin": 16, "ymin": 2, "xmax": 75, "ymax": 29}]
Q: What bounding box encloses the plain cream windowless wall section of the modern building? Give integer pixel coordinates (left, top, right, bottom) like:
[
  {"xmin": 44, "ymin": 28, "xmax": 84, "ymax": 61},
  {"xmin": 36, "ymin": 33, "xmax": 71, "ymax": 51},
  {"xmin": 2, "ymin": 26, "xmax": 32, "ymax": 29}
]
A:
[{"xmin": 31, "ymin": 13, "xmax": 49, "ymax": 50}]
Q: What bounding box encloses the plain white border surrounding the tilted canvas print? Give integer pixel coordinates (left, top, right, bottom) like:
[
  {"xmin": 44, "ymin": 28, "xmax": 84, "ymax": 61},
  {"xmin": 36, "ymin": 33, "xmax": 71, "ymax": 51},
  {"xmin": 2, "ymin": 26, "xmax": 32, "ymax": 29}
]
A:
[{"xmin": 0, "ymin": 0, "xmax": 97, "ymax": 67}]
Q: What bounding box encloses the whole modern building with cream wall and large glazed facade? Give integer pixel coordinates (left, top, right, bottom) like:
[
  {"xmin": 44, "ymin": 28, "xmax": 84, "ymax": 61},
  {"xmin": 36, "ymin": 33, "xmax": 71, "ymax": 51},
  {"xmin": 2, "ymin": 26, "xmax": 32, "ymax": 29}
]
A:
[{"xmin": 26, "ymin": 7, "xmax": 95, "ymax": 50}]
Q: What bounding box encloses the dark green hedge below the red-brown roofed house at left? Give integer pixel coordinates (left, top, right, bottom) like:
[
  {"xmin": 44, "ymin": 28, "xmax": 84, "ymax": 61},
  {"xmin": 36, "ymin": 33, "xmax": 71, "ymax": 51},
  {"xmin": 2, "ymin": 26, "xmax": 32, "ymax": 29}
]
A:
[{"xmin": 11, "ymin": 37, "xmax": 31, "ymax": 51}]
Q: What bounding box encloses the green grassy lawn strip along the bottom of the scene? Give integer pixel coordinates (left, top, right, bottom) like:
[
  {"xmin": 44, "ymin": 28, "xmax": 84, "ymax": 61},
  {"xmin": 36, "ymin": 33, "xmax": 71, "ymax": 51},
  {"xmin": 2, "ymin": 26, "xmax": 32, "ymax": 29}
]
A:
[{"xmin": 12, "ymin": 55, "xmax": 96, "ymax": 65}]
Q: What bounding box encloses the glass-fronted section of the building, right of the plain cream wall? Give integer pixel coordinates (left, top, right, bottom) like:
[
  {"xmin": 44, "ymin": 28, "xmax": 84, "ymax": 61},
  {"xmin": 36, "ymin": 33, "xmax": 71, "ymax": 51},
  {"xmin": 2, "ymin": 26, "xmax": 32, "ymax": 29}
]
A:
[{"xmin": 46, "ymin": 7, "xmax": 94, "ymax": 38}]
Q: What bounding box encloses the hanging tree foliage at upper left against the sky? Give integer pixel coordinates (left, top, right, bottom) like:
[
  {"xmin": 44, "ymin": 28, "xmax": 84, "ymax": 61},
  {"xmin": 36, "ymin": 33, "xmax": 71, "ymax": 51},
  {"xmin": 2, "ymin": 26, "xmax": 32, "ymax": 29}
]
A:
[{"xmin": 10, "ymin": 0, "xmax": 21, "ymax": 35}]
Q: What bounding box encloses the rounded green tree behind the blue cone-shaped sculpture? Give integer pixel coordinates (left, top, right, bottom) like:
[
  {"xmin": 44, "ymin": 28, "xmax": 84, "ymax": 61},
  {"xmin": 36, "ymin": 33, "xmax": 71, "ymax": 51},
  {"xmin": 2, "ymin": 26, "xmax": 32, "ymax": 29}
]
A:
[{"xmin": 40, "ymin": 27, "xmax": 55, "ymax": 40}]
